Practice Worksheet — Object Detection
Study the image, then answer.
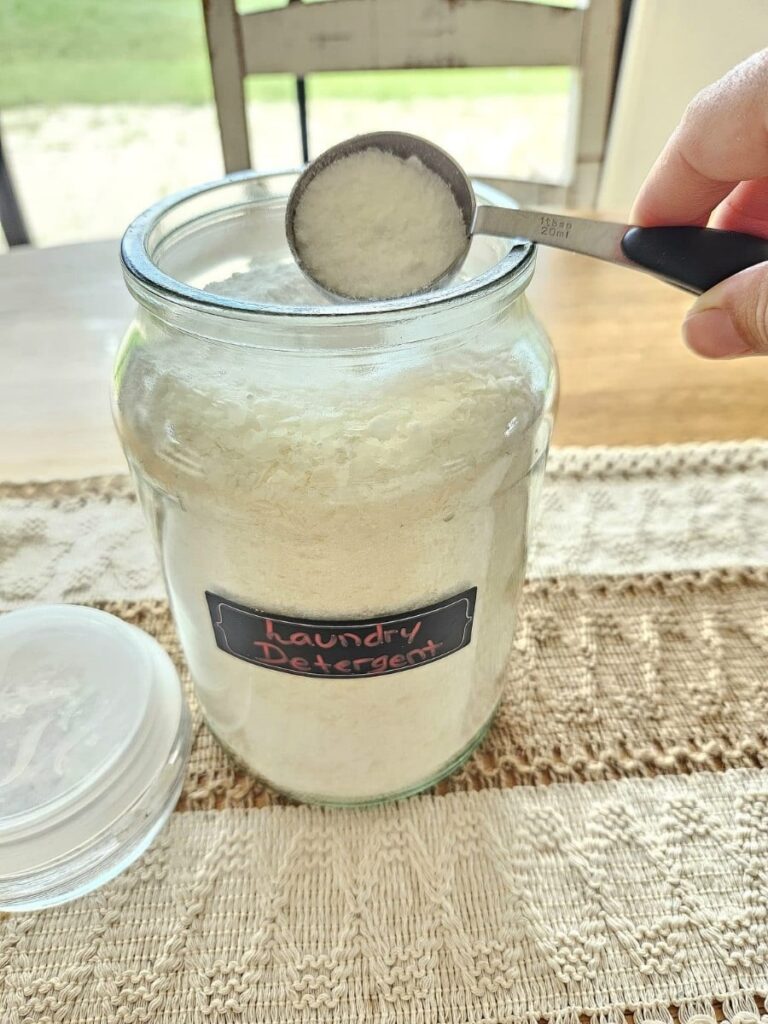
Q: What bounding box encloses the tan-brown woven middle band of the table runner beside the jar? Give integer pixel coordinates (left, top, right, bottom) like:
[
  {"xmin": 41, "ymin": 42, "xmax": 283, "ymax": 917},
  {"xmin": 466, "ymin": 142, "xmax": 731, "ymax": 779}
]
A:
[{"xmin": 94, "ymin": 568, "xmax": 768, "ymax": 810}]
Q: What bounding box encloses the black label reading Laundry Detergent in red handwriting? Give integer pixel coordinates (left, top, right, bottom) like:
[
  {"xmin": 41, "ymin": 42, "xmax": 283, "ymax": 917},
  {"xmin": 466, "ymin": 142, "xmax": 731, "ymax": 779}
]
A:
[{"xmin": 206, "ymin": 587, "xmax": 477, "ymax": 679}]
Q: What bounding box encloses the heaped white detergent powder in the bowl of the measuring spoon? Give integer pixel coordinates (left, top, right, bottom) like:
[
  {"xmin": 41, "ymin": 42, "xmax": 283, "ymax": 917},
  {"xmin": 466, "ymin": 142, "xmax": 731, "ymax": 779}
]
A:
[{"xmin": 294, "ymin": 148, "xmax": 467, "ymax": 299}]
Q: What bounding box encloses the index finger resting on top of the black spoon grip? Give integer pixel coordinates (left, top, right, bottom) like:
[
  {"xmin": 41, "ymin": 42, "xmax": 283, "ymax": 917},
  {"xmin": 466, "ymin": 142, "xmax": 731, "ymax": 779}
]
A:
[{"xmin": 632, "ymin": 49, "xmax": 768, "ymax": 225}]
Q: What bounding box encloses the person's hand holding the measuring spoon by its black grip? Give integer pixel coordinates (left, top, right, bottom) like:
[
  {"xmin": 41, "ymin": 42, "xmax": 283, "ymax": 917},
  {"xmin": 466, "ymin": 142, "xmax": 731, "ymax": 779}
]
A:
[{"xmin": 632, "ymin": 49, "xmax": 768, "ymax": 359}]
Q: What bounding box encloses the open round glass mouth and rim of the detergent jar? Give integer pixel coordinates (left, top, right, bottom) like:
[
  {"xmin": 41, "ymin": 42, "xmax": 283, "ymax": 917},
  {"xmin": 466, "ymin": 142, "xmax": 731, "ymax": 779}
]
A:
[{"xmin": 121, "ymin": 171, "xmax": 536, "ymax": 319}]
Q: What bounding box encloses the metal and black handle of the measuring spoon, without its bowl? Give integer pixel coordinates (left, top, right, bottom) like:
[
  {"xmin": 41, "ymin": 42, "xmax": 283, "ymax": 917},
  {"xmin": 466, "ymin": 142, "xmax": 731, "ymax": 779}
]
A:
[{"xmin": 473, "ymin": 206, "xmax": 768, "ymax": 295}]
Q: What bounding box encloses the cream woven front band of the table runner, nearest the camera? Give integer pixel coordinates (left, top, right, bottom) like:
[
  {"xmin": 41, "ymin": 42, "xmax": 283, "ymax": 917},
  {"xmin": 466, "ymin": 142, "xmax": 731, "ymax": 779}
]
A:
[{"xmin": 0, "ymin": 770, "xmax": 768, "ymax": 1024}]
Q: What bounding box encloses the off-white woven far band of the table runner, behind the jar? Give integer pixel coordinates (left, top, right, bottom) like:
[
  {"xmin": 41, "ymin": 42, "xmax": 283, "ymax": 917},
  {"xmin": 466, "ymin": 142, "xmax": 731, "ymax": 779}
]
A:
[{"xmin": 0, "ymin": 441, "xmax": 768, "ymax": 608}]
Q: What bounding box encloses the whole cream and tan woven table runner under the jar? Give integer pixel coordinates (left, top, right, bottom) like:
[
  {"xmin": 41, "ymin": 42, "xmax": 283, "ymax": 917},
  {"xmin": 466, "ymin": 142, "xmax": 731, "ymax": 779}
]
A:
[{"xmin": 0, "ymin": 442, "xmax": 768, "ymax": 1024}]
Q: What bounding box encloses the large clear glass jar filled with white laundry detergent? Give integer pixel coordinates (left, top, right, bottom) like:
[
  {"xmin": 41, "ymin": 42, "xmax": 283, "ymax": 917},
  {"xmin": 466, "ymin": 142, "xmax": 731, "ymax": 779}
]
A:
[{"xmin": 114, "ymin": 173, "xmax": 556, "ymax": 804}]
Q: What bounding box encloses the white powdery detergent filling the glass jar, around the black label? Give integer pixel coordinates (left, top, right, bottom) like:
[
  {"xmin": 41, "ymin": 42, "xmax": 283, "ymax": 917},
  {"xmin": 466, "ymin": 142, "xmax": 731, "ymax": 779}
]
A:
[{"xmin": 120, "ymin": 276, "xmax": 544, "ymax": 801}]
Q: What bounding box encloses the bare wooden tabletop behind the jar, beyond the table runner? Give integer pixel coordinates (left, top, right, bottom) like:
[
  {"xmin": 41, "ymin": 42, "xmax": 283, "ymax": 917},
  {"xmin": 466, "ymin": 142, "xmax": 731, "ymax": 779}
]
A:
[{"xmin": 0, "ymin": 242, "xmax": 768, "ymax": 480}]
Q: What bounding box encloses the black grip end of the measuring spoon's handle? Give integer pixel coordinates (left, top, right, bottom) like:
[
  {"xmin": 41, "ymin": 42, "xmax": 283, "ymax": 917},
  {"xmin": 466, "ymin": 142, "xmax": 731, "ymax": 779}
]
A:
[{"xmin": 622, "ymin": 227, "xmax": 768, "ymax": 295}]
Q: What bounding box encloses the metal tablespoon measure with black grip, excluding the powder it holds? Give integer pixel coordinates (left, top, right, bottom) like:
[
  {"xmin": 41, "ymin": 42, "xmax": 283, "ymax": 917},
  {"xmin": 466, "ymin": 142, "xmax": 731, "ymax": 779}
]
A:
[{"xmin": 286, "ymin": 132, "xmax": 768, "ymax": 295}]
